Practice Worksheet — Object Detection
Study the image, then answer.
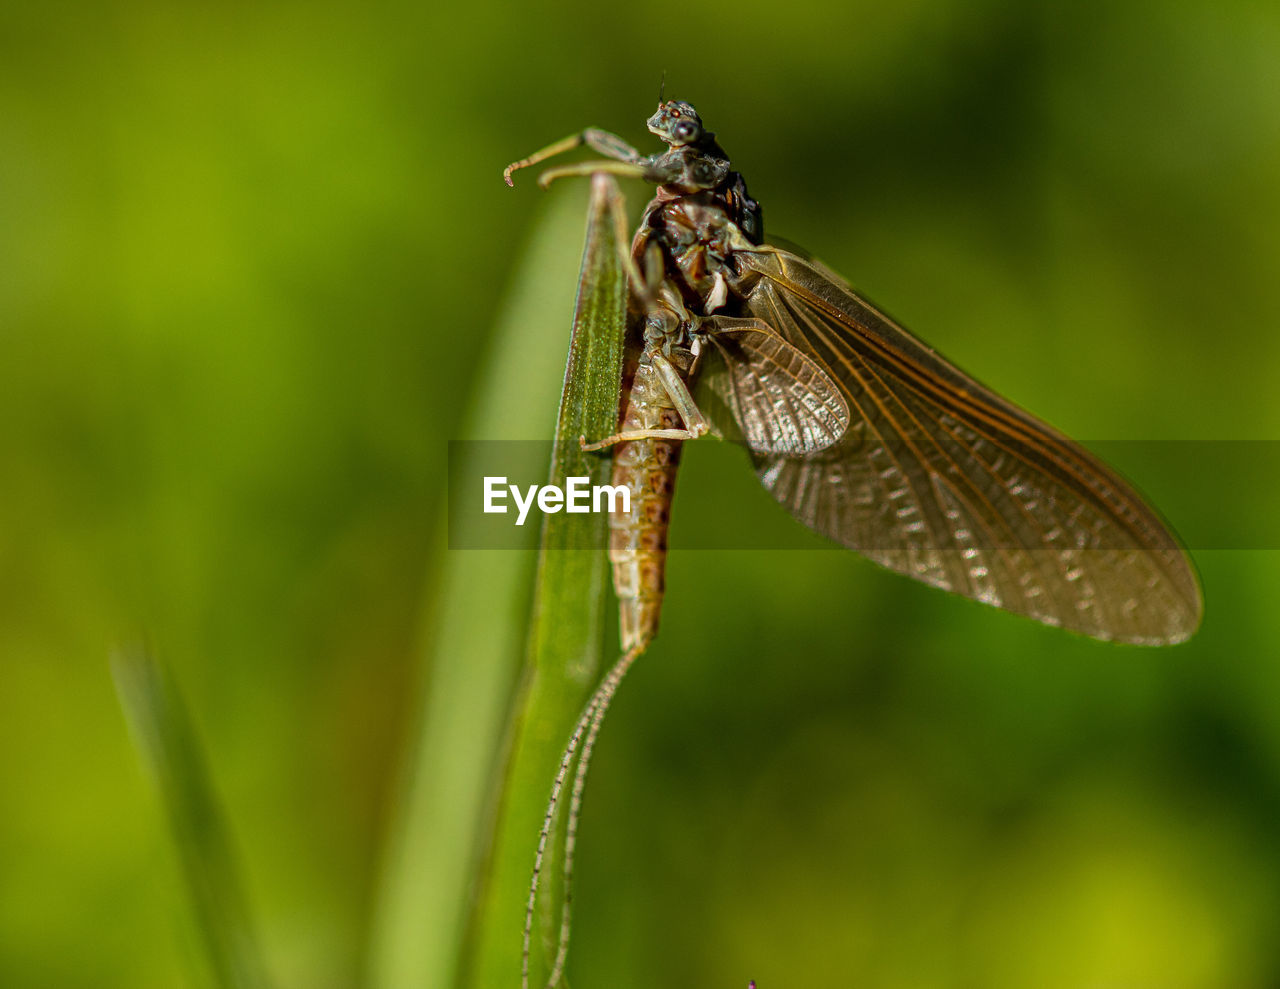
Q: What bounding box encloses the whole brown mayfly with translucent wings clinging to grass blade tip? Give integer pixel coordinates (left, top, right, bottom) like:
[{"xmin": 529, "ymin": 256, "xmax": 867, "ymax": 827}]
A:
[{"xmin": 504, "ymin": 100, "xmax": 1202, "ymax": 986}]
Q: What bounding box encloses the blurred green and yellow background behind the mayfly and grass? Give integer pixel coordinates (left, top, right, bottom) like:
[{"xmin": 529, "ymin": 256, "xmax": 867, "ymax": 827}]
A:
[{"xmin": 0, "ymin": 0, "xmax": 1280, "ymax": 989}]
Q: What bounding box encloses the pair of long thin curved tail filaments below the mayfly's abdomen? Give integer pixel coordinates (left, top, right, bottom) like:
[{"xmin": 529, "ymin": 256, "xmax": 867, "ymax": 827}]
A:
[{"xmin": 520, "ymin": 644, "xmax": 646, "ymax": 989}]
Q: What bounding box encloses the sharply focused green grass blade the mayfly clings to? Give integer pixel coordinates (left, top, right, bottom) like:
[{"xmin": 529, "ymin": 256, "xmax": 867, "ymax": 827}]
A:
[{"xmin": 465, "ymin": 179, "xmax": 626, "ymax": 986}]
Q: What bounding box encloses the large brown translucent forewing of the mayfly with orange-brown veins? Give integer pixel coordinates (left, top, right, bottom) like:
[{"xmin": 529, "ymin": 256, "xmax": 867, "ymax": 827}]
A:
[{"xmin": 737, "ymin": 251, "xmax": 1202, "ymax": 645}]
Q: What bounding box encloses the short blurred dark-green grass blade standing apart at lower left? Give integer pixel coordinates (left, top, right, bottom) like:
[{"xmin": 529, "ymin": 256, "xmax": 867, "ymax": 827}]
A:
[{"xmin": 111, "ymin": 647, "xmax": 269, "ymax": 989}]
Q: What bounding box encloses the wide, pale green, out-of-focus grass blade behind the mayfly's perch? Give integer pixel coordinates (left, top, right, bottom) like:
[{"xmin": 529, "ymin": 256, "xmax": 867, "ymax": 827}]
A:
[{"xmin": 370, "ymin": 183, "xmax": 621, "ymax": 989}]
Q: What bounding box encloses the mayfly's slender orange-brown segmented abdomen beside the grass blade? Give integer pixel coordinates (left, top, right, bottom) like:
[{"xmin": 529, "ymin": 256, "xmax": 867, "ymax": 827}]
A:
[{"xmin": 609, "ymin": 357, "xmax": 684, "ymax": 651}]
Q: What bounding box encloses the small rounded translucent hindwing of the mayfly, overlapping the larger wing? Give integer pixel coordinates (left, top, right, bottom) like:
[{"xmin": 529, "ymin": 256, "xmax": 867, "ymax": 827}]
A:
[{"xmin": 700, "ymin": 319, "xmax": 849, "ymax": 457}]
